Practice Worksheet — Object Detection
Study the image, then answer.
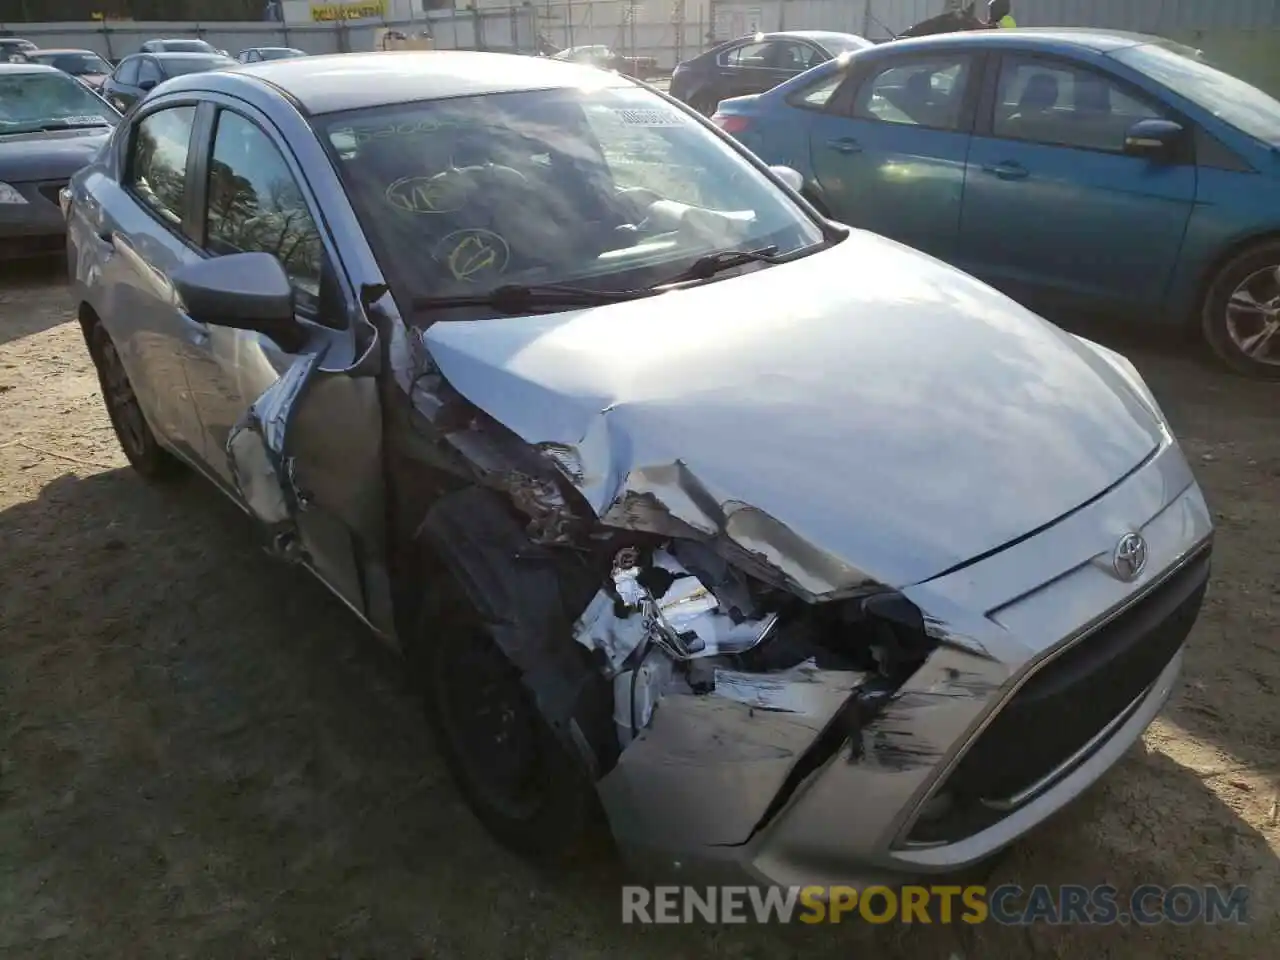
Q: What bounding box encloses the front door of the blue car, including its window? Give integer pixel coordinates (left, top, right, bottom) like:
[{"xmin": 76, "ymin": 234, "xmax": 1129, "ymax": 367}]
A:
[{"xmin": 957, "ymin": 54, "xmax": 1197, "ymax": 310}]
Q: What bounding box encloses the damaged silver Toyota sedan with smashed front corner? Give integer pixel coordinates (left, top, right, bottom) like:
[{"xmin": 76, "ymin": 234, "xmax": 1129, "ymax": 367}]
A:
[{"xmin": 64, "ymin": 52, "xmax": 1212, "ymax": 883}]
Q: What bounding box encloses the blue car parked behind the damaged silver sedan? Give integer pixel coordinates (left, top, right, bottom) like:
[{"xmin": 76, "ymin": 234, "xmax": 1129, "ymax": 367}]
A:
[{"xmin": 713, "ymin": 29, "xmax": 1280, "ymax": 379}]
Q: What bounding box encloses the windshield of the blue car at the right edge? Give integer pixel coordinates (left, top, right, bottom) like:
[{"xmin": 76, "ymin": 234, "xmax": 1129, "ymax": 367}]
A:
[{"xmin": 1112, "ymin": 41, "xmax": 1280, "ymax": 143}]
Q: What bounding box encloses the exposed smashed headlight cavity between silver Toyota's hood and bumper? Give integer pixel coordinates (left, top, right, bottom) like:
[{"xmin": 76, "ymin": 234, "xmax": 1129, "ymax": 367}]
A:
[{"xmin": 573, "ymin": 540, "xmax": 933, "ymax": 748}]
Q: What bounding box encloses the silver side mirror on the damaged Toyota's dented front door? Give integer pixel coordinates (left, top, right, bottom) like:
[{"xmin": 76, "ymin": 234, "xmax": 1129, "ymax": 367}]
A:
[{"xmin": 173, "ymin": 253, "xmax": 305, "ymax": 352}]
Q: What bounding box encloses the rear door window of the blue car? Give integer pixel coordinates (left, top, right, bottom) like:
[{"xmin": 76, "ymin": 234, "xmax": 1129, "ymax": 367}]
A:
[{"xmin": 854, "ymin": 56, "xmax": 972, "ymax": 131}]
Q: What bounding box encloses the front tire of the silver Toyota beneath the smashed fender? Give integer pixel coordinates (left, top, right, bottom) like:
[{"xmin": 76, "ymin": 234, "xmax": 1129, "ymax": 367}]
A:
[{"xmin": 411, "ymin": 582, "xmax": 598, "ymax": 865}]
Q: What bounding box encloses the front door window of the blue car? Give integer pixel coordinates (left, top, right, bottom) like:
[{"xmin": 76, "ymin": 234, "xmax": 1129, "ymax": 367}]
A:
[{"xmin": 991, "ymin": 56, "xmax": 1162, "ymax": 154}]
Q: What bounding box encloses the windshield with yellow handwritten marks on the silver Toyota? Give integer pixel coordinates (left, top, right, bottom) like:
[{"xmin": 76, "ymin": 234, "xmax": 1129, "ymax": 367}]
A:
[{"xmin": 319, "ymin": 86, "xmax": 823, "ymax": 316}]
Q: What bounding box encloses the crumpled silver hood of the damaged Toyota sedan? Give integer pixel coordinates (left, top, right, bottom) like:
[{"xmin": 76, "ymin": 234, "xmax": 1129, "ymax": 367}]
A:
[{"xmin": 425, "ymin": 230, "xmax": 1162, "ymax": 596}]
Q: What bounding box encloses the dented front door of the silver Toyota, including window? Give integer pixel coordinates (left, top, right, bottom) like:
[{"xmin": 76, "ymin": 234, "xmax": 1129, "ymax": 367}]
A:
[{"xmin": 177, "ymin": 104, "xmax": 392, "ymax": 634}]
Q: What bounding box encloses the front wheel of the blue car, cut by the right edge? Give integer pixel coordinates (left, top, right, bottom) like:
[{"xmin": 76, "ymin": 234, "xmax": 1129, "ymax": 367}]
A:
[{"xmin": 1201, "ymin": 241, "xmax": 1280, "ymax": 380}]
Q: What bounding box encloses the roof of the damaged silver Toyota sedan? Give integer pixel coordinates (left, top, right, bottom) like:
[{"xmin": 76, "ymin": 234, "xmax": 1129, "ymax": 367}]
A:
[{"xmin": 185, "ymin": 50, "xmax": 632, "ymax": 114}]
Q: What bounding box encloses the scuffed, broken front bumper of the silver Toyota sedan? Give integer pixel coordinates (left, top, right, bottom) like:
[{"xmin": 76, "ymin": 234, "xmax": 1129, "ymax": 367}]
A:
[{"xmin": 600, "ymin": 442, "xmax": 1212, "ymax": 887}]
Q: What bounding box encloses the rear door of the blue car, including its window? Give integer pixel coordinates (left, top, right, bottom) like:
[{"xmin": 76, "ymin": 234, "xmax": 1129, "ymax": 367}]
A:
[{"xmin": 809, "ymin": 50, "xmax": 980, "ymax": 260}]
